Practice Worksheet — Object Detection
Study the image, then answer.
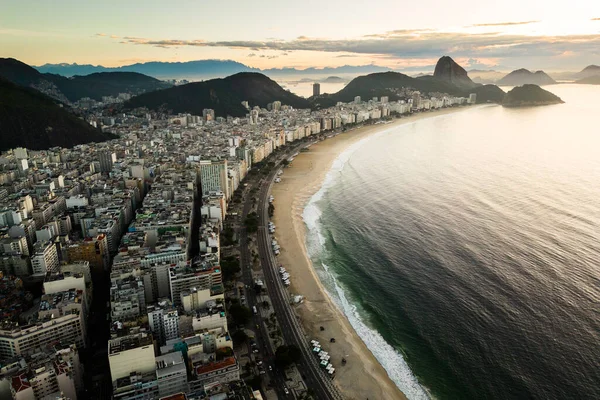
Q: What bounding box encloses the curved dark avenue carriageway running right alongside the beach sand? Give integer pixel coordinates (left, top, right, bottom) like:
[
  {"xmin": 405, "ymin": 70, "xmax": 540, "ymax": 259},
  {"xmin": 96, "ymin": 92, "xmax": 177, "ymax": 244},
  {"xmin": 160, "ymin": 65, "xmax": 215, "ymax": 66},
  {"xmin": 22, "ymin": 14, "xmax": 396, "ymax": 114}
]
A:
[{"xmin": 248, "ymin": 140, "xmax": 343, "ymax": 399}]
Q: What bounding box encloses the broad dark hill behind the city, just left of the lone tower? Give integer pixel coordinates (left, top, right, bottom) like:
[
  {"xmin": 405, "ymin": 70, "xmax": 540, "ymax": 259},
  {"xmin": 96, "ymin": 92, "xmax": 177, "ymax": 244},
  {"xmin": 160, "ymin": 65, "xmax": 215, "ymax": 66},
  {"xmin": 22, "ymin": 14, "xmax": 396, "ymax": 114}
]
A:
[{"xmin": 125, "ymin": 72, "xmax": 310, "ymax": 117}]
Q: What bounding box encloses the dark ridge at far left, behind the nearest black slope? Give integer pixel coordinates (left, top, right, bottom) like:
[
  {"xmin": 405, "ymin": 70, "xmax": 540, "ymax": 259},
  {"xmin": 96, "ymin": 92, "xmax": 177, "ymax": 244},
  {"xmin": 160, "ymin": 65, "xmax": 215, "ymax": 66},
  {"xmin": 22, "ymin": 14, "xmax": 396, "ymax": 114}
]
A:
[{"xmin": 0, "ymin": 58, "xmax": 172, "ymax": 103}]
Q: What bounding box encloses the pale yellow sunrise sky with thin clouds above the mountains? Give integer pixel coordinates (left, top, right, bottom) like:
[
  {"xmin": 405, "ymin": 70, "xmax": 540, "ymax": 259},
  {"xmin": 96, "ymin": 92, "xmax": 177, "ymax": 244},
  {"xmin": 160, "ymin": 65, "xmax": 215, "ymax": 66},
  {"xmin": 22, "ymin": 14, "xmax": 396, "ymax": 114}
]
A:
[{"xmin": 0, "ymin": 0, "xmax": 600, "ymax": 71}]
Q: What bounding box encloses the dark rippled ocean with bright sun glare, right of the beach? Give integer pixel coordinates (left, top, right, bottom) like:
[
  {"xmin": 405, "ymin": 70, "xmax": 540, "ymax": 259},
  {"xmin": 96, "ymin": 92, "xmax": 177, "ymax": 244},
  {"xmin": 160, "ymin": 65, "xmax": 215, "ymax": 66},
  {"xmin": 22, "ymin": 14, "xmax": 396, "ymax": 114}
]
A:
[{"xmin": 303, "ymin": 85, "xmax": 600, "ymax": 400}]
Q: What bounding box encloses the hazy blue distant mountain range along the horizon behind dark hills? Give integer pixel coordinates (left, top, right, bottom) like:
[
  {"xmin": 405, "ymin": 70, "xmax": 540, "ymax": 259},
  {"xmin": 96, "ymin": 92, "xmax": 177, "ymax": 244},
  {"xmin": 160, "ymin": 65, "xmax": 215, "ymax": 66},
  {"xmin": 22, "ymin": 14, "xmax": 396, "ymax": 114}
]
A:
[{"xmin": 35, "ymin": 60, "xmax": 389, "ymax": 80}]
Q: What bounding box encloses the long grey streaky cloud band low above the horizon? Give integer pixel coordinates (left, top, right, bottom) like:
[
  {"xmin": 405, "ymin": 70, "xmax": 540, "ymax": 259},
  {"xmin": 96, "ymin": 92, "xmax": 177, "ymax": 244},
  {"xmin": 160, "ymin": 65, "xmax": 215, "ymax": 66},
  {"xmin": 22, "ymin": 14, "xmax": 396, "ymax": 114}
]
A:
[{"xmin": 105, "ymin": 28, "xmax": 600, "ymax": 68}]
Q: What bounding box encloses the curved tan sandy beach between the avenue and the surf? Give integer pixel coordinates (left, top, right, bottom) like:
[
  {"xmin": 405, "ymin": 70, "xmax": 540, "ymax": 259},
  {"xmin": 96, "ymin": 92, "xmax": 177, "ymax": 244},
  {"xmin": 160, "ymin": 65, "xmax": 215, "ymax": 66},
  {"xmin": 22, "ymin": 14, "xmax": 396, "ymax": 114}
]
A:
[{"xmin": 272, "ymin": 108, "xmax": 464, "ymax": 400}]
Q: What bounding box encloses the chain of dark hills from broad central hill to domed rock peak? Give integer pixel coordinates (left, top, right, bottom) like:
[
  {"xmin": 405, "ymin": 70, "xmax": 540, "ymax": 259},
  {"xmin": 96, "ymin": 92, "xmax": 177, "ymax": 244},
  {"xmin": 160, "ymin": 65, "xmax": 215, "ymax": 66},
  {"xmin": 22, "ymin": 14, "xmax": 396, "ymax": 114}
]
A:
[{"xmin": 125, "ymin": 57, "xmax": 505, "ymax": 116}]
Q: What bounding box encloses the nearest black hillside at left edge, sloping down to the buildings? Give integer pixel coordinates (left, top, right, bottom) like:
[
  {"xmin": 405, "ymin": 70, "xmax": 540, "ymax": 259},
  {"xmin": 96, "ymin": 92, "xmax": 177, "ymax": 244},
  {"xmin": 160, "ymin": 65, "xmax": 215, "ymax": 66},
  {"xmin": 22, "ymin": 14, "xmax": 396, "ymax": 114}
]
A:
[{"xmin": 0, "ymin": 78, "xmax": 112, "ymax": 151}]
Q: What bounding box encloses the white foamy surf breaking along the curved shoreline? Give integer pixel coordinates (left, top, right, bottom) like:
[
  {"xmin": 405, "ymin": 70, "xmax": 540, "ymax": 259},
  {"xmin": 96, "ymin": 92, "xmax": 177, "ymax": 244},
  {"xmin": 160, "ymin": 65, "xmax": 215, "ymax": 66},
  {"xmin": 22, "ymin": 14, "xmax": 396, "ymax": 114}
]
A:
[{"xmin": 302, "ymin": 128, "xmax": 431, "ymax": 400}]
